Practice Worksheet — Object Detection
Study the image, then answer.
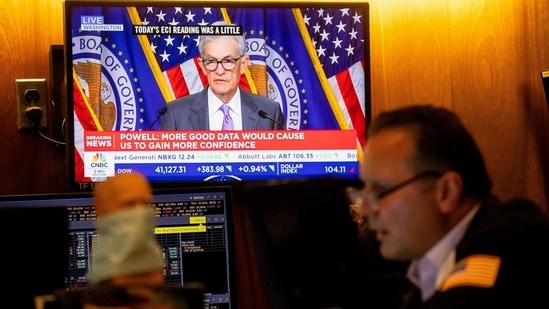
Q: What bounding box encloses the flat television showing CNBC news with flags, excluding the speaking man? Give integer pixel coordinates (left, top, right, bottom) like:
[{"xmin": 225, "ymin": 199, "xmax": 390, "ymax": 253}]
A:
[{"xmin": 64, "ymin": 0, "xmax": 370, "ymax": 190}]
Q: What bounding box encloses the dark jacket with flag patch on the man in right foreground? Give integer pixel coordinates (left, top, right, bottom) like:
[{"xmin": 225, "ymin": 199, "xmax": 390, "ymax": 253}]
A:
[{"xmin": 406, "ymin": 197, "xmax": 549, "ymax": 309}]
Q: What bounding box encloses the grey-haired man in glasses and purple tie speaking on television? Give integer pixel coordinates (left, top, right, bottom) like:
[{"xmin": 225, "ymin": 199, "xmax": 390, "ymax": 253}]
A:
[{"xmin": 161, "ymin": 22, "xmax": 285, "ymax": 130}]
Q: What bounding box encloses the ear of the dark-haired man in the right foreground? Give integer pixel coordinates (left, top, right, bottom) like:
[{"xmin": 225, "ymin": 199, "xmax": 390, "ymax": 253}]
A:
[{"xmin": 436, "ymin": 171, "xmax": 463, "ymax": 213}]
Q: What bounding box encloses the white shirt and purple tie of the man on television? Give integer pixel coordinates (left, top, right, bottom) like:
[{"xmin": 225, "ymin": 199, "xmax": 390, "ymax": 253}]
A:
[{"xmin": 208, "ymin": 88, "xmax": 242, "ymax": 131}]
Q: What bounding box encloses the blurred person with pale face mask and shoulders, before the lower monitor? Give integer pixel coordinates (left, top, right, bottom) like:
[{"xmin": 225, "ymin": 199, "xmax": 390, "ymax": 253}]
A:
[{"xmin": 55, "ymin": 173, "xmax": 204, "ymax": 309}]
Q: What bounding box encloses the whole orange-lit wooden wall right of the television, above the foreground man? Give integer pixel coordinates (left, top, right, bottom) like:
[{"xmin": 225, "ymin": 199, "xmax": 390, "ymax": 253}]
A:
[{"xmin": 370, "ymin": 0, "xmax": 549, "ymax": 207}]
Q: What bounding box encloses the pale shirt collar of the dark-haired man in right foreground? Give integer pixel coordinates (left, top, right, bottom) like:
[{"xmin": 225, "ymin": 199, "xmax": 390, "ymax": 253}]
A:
[{"xmin": 407, "ymin": 204, "xmax": 480, "ymax": 301}]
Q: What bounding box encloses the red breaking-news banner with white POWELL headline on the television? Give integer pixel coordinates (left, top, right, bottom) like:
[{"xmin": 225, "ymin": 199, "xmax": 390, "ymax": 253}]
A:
[{"xmin": 84, "ymin": 130, "xmax": 357, "ymax": 153}]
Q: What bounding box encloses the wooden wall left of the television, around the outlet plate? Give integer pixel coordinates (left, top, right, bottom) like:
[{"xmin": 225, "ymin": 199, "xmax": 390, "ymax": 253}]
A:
[{"xmin": 0, "ymin": 0, "xmax": 67, "ymax": 194}]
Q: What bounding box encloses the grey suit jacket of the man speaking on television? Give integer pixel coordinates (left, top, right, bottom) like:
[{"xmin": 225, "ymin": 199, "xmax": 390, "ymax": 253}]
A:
[{"xmin": 160, "ymin": 88, "xmax": 285, "ymax": 130}]
